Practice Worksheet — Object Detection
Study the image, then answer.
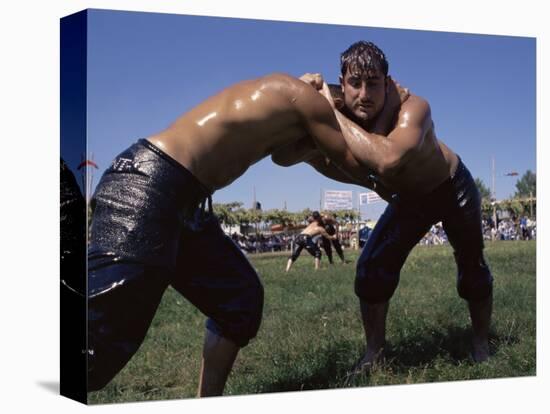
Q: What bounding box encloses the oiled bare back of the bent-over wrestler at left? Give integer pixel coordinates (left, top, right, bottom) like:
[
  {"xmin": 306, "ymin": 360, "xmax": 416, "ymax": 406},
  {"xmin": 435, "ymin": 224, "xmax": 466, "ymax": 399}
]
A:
[{"xmin": 148, "ymin": 74, "xmax": 350, "ymax": 190}]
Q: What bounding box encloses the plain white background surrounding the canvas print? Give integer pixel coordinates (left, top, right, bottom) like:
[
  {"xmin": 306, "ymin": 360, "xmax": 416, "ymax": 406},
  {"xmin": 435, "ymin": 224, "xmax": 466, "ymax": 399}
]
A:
[{"xmin": 0, "ymin": 0, "xmax": 550, "ymax": 414}]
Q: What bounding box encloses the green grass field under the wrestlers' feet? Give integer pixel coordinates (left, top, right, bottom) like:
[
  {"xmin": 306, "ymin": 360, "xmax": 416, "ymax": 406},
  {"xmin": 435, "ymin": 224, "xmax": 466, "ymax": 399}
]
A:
[{"xmin": 89, "ymin": 242, "xmax": 536, "ymax": 404}]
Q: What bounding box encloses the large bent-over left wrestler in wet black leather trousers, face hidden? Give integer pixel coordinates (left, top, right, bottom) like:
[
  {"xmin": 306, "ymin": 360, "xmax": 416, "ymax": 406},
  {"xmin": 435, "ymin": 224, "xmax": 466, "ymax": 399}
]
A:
[{"xmin": 88, "ymin": 74, "xmax": 374, "ymax": 396}]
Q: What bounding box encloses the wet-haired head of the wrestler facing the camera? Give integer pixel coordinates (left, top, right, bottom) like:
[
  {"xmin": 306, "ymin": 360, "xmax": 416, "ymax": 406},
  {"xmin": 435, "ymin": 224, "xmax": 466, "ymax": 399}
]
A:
[{"xmin": 340, "ymin": 41, "xmax": 389, "ymax": 124}]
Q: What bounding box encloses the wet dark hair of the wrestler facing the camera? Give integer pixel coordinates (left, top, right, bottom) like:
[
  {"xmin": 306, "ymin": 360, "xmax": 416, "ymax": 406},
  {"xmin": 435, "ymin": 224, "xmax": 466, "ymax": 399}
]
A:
[{"xmin": 340, "ymin": 40, "xmax": 389, "ymax": 77}]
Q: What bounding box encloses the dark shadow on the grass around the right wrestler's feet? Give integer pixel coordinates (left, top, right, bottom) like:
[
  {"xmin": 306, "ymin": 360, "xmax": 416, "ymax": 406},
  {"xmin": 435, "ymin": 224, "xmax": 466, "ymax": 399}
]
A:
[{"xmin": 252, "ymin": 326, "xmax": 519, "ymax": 392}]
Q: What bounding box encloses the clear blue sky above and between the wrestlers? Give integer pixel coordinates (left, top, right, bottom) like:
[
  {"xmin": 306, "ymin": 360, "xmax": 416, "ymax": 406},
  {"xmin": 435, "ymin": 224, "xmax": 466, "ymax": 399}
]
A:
[{"xmin": 72, "ymin": 10, "xmax": 536, "ymax": 218}]
